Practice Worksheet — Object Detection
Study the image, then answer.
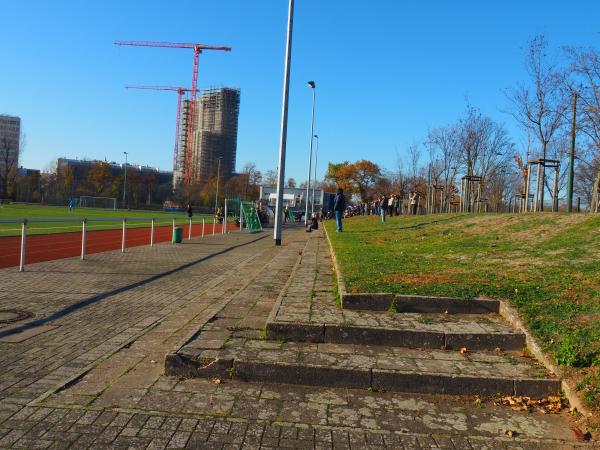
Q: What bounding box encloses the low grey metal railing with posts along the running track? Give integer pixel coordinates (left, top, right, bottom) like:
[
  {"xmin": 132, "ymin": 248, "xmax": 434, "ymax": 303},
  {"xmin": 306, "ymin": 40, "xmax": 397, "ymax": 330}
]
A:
[{"xmin": 0, "ymin": 217, "xmax": 227, "ymax": 272}]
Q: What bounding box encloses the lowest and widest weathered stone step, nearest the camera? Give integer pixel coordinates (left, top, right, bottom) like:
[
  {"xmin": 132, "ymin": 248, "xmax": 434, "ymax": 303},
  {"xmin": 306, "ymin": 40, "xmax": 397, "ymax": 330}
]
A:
[{"xmin": 165, "ymin": 338, "xmax": 560, "ymax": 397}]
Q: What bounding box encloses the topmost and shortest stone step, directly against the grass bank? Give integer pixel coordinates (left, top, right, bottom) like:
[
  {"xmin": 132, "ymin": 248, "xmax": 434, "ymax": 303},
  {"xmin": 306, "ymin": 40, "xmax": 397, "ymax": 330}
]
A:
[{"xmin": 342, "ymin": 294, "xmax": 500, "ymax": 314}]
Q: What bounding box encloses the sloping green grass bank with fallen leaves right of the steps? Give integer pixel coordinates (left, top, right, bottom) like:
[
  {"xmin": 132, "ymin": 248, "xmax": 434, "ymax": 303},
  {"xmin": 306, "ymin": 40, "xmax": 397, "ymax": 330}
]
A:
[{"xmin": 326, "ymin": 213, "xmax": 600, "ymax": 409}]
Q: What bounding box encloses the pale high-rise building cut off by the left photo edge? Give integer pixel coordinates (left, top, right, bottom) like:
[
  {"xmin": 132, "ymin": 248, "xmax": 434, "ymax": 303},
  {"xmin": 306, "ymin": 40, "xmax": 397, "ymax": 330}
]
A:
[{"xmin": 0, "ymin": 115, "xmax": 21, "ymax": 197}]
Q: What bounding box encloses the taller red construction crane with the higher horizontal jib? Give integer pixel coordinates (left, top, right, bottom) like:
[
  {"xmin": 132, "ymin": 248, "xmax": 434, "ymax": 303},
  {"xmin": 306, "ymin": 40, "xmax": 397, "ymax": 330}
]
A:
[{"xmin": 115, "ymin": 41, "xmax": 231, "ymax": 183}]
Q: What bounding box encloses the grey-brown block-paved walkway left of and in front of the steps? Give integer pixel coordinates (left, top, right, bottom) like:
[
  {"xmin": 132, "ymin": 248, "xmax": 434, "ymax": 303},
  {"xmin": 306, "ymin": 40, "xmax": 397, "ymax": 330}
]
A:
[{"xmin": 0, "ymin": 231, "xmax": 590, "ymax": 449}]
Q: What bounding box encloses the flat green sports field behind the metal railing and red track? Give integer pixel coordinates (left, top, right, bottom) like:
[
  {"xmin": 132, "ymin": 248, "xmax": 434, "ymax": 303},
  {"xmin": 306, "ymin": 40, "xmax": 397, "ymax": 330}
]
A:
[{"xmin": 0, "ymin": 205, "xmax": 213, "ymax": 237}]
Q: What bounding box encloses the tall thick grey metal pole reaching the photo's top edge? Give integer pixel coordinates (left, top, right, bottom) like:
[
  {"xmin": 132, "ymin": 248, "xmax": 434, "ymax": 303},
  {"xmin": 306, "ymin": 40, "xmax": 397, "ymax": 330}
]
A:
[{"xmin": 273, "ymin": 0, "xmax": 294, "ymax": 245}]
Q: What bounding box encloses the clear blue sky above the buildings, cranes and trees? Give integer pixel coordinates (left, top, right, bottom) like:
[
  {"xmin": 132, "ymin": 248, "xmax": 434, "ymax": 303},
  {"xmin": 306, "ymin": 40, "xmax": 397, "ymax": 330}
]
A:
[{"xmin": 0, "ymin": 0, "xmax": 600, "ymax": 181}]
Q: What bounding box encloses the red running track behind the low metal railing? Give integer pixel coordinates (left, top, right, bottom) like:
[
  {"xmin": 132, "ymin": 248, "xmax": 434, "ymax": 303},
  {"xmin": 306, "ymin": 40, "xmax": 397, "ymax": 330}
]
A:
[{"xmin": 0, "ymin": 223, "xmax": 237, "ymax": 269}]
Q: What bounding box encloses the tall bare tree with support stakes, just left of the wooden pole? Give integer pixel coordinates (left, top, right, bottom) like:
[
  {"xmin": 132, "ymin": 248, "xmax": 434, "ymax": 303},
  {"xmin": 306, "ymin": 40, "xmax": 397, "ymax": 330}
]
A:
[{"xmin": 508, "ymin": 35, "xmax": 568, "ymax": 210}]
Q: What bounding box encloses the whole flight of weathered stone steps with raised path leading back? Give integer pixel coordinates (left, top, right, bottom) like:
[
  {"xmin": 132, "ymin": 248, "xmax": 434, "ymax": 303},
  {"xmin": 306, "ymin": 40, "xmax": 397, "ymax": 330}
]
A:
[{"xmin": 165, "ymin": 235, "xmax": 560, "ymax": 397}]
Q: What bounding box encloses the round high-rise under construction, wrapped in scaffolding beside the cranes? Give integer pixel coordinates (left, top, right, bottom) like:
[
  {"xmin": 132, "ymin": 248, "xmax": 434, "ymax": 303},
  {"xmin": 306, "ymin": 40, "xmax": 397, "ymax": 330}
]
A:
[{"xmin": 173, "ymin": 88, "xmax": 240, "ymax": 186}]
